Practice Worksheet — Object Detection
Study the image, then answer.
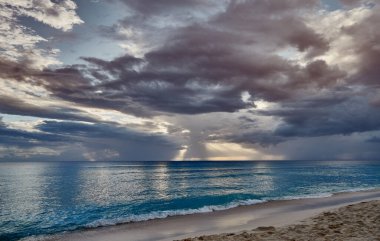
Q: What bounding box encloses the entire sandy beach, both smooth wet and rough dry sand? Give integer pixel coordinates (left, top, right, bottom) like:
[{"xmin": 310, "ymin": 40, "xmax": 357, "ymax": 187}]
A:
[{"xmin": 38, "ymin": 190, "xmax": 380, "ymax": 241}]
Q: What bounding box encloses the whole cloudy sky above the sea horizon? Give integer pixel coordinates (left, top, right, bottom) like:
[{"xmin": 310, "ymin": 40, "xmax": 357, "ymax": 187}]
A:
[{"xmin": 0, "ymin": 0, "xmax": 380, "ymax": 161}]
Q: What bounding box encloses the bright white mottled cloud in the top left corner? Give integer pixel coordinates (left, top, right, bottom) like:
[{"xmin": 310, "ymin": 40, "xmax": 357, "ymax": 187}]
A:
[{"xmin": 0, "ymin": 0, "xmax": 83, "ymax": 69}]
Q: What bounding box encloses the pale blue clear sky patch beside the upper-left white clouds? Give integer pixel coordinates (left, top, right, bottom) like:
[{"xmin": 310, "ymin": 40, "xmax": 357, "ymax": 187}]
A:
[{"xmin": 20, "ymin": 0, "xmax": 131, "ymax": 65}]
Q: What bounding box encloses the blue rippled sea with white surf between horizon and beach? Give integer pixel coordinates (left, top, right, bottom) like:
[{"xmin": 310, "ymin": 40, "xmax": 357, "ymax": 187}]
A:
[{"xmin": 0, "ymin": 161, "xmax": 380, "ymax": 241}]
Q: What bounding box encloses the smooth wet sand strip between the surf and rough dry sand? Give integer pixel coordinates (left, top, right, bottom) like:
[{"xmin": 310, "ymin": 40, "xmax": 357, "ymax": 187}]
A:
[{"xmin": 32, "ymin": 189, "xmax": 380, "ymax": 241}]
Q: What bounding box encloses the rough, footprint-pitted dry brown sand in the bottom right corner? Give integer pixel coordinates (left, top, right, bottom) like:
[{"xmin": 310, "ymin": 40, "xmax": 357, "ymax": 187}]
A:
[{"xmin": 178, "ymin": 200, "xmax": 380, "ymax": 241}]
